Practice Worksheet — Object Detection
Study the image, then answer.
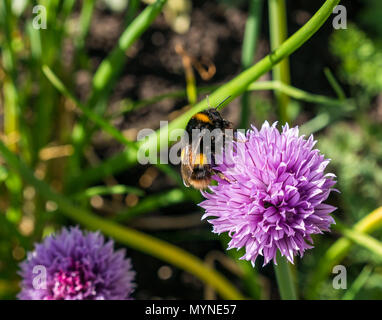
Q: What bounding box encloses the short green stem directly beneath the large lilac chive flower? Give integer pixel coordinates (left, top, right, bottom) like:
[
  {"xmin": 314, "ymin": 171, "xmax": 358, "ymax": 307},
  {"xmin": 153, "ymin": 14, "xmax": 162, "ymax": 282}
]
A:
[{"xmin": 274, "ymin": 253, "xmax": 297, "ymax": 300}]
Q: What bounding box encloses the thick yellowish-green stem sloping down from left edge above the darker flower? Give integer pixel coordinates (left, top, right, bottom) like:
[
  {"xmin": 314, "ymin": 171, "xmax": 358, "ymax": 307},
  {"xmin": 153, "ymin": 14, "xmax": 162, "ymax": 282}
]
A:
[{"xmin": 0, "ymin": 141, "xmax": 244, "ymax": 299}]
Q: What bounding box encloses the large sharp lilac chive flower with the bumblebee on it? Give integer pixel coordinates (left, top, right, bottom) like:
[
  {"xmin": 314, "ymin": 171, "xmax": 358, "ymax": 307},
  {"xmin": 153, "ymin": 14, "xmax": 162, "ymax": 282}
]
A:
[{"xmin": 200, "ymin": 122, "xmax": 336, "ymax": 265}]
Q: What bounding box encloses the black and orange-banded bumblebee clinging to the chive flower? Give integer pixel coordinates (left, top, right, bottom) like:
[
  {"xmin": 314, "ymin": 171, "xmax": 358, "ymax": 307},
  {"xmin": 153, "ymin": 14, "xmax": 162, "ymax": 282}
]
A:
[{"xmin": 181, "ymin": 98, "xmax": 232, "ymax": 189}]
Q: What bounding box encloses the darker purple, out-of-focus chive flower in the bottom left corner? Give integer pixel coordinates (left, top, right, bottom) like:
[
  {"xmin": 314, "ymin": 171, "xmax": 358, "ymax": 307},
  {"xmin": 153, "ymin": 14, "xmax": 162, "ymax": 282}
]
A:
[{"xmin": 18, "ymin": 227, "xmax": 135, "ymax": 300}]
